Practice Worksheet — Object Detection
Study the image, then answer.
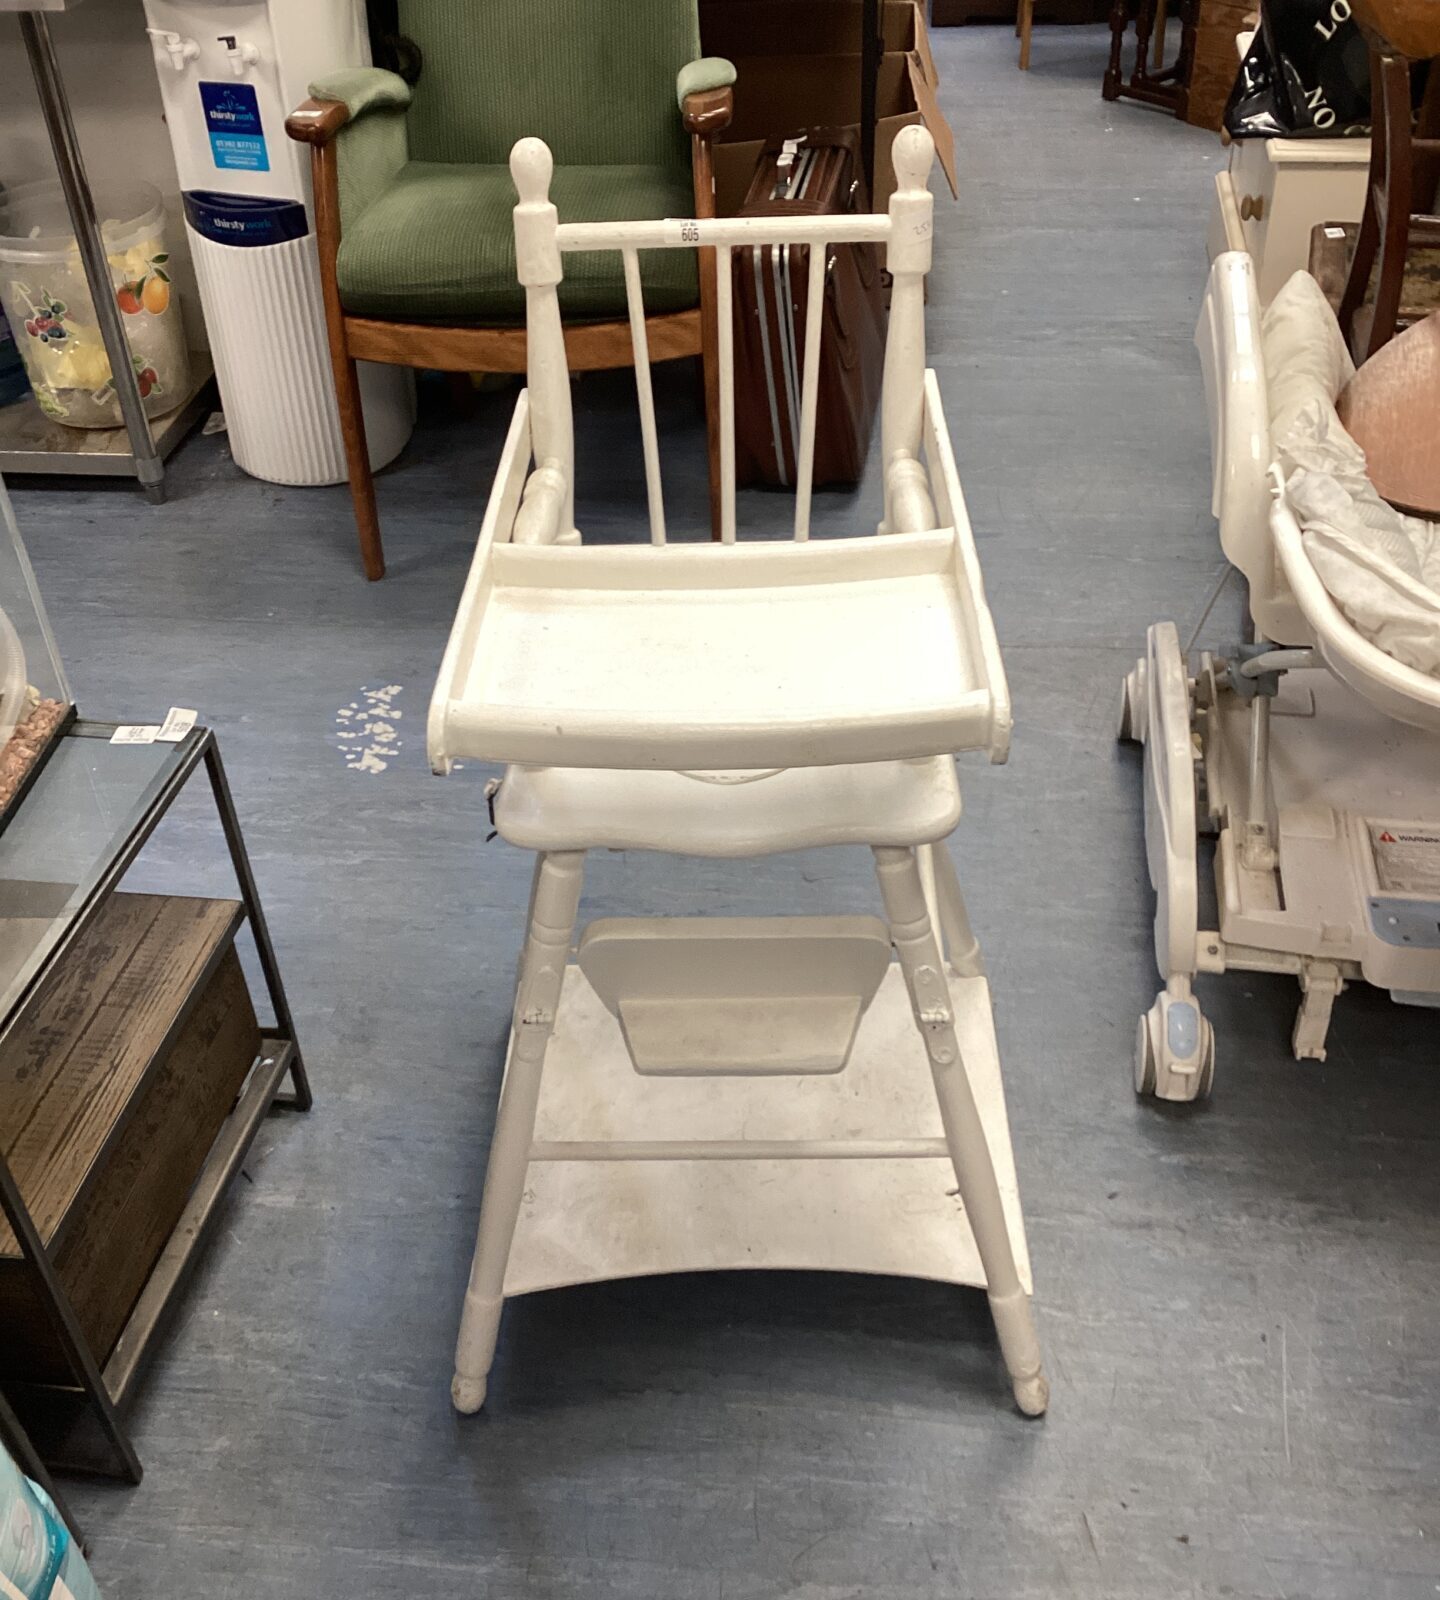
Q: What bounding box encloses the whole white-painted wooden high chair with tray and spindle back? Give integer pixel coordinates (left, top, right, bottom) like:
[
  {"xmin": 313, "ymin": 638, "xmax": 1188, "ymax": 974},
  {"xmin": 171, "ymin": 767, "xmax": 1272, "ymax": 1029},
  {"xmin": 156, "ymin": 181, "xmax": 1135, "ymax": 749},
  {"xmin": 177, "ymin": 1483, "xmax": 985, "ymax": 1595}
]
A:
[{"xmin": 429, "ymin": 126, "xmax": 1048, "ymax": 1416}]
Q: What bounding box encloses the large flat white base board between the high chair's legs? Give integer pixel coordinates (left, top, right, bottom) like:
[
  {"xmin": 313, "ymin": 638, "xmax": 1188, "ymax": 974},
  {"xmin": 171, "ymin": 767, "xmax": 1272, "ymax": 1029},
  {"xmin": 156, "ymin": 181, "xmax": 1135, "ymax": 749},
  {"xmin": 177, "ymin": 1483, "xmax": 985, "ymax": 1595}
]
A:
[{"xmin": 504, "ymin": 960, "xmax": 1030, "ymax": 1296}]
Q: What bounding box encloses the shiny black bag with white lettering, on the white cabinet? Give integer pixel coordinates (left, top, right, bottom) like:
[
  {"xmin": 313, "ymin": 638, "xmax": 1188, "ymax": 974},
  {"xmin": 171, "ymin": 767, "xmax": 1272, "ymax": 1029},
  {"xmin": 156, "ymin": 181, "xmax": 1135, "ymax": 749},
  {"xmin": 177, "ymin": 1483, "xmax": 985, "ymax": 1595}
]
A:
[{"xmin": 1226, "ymin": 0, "xmax": 1370, "ymax": 139}]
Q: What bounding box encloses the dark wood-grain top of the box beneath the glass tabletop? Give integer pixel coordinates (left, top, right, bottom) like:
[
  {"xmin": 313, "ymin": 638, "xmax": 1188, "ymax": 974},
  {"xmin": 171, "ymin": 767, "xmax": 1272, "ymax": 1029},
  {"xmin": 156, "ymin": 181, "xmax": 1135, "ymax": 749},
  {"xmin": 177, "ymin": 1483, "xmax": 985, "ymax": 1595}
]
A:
[{"xmin": 0, "ymin": 894, "xmax": 245, "ymax": 1258}]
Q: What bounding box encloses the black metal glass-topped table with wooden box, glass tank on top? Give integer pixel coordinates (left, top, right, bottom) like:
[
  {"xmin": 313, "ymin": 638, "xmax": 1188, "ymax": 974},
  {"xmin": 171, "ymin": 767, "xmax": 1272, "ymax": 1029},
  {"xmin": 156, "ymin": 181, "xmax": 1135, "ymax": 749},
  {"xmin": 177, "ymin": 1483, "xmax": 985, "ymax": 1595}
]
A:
[{"xmin": 0, "ymin": 483, "xmax": 310, "ymax": 1482}]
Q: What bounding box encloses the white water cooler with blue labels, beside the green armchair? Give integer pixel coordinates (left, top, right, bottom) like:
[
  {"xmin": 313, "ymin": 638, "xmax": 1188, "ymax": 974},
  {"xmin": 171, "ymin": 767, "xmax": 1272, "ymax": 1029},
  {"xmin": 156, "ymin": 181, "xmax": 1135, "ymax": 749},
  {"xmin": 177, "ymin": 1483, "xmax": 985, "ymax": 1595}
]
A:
[{"xmin": 146, "ymin": 0, "xmax": 414, "ymax": 483}]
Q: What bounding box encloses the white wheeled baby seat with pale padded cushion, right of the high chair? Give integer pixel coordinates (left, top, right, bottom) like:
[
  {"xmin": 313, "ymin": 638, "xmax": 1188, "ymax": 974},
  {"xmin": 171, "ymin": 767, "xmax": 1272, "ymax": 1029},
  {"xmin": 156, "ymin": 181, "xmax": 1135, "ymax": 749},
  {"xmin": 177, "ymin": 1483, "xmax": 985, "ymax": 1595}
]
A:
[{"xmin": 1120, "ymin": 251, "xmax": 1440, "ymax": 1101}]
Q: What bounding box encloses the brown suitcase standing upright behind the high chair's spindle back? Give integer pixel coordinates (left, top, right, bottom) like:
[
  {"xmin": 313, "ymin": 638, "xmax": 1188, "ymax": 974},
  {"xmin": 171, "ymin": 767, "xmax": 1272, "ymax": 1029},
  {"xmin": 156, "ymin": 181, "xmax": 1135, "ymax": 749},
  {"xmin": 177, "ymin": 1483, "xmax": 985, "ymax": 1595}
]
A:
[{"xmin": 731, "ymin": 128, "xmax": 885, "ymax": 486}]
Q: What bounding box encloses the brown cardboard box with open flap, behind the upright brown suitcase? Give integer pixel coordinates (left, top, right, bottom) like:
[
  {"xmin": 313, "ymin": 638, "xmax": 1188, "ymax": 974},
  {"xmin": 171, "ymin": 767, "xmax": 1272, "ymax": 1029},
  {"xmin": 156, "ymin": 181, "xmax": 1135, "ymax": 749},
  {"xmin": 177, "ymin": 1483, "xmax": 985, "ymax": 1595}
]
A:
[{"xmin": 715, "ymin": 51, "xmax": 960, "ymax": 216}]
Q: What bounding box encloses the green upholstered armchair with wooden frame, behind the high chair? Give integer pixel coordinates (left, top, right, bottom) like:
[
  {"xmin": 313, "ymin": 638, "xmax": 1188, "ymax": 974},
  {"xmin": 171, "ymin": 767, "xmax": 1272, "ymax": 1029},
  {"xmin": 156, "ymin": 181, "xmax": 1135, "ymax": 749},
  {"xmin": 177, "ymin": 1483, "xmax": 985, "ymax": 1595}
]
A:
[{"xmin": 286, "ymin": 0, "xmax": 734, "ymax": 578}]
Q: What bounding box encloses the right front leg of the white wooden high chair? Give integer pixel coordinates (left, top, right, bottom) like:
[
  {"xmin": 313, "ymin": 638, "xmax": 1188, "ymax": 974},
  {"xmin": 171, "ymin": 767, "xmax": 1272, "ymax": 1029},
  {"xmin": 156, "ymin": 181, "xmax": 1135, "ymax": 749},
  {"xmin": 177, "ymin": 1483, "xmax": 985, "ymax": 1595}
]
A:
[{"xmin": 875, "ymin": 846, "xmax": 1050, "ymax": 1416}]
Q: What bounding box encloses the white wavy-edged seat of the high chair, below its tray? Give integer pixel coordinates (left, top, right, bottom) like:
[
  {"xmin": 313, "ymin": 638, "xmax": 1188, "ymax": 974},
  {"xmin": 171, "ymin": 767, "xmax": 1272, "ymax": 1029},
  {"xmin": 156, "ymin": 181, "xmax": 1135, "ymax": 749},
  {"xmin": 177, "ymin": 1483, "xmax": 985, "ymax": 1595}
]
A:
[{"xmin": 494, "ymin": 755, "xmax": 960, "ymax": 856}]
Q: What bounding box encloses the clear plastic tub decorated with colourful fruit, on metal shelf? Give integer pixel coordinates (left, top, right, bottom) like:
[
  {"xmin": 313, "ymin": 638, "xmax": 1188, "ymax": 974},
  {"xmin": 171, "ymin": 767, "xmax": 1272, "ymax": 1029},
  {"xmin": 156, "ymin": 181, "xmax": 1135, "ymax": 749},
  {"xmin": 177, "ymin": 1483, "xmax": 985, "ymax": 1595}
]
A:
[{"xmin": 0, "ymin": 182, "xmax": 190, "ymax": 427}]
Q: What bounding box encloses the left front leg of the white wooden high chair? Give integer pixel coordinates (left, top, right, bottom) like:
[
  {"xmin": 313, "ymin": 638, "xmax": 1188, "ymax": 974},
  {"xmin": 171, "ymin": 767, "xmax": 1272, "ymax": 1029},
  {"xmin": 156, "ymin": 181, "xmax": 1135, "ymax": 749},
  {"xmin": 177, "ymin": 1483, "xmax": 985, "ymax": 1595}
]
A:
[{"xmin": 450, "ymin": 851, "xmax": 586, "ymax": 1411}]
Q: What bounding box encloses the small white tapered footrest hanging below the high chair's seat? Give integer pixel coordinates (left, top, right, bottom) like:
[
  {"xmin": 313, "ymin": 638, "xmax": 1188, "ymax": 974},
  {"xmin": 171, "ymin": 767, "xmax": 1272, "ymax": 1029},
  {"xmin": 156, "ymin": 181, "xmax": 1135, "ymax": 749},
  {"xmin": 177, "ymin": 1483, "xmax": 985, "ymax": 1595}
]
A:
[{"xmin": 578, "ymin": 917, "xmax": 890, "ymax": 1077}]
